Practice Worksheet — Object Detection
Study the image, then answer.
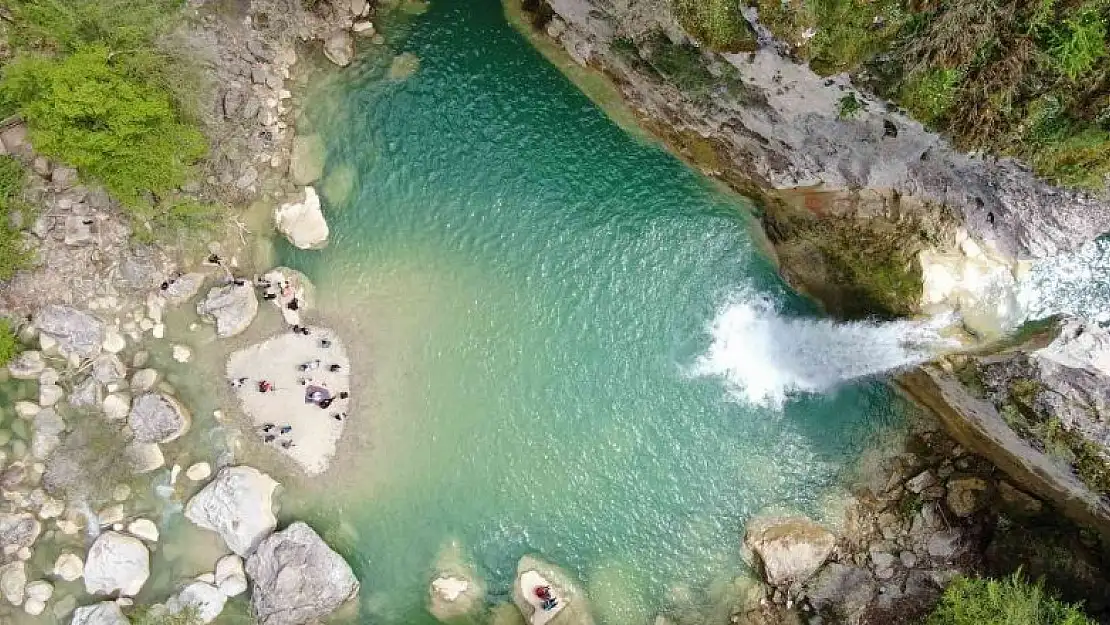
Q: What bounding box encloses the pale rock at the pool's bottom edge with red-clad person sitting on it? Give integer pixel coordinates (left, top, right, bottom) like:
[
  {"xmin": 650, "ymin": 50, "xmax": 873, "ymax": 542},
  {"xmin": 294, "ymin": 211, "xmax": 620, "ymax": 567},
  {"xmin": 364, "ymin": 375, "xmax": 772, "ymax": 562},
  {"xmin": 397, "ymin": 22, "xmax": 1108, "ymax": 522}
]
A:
[{"xmin": 513, "ymin": 555, "xmax": 594, "ymax": 625}]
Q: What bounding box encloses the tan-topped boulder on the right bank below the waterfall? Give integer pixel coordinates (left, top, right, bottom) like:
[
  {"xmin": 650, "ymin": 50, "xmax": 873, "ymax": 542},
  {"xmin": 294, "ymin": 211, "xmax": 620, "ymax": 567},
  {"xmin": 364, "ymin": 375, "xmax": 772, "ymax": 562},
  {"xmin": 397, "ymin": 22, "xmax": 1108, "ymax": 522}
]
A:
[{"xmin": 744, "ymin": 516, "xmax": 836, "ymax": 586}]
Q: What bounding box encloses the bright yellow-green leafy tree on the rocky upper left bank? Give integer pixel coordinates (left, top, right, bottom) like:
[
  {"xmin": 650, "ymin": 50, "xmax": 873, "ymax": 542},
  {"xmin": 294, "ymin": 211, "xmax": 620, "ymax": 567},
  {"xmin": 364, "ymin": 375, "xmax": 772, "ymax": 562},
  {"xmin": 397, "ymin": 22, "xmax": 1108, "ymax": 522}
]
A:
[{"xmin": 0, "ymin": 46, "xmax": 206, "ymax": 208}]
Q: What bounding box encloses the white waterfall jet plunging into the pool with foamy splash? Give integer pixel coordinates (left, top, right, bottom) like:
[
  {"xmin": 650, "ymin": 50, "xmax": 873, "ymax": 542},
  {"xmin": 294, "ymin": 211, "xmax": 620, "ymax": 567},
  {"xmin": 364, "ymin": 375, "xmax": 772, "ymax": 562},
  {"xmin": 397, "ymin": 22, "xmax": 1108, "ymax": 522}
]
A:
[{"xmin": 693, "ymin": 292, "xmax": 958, "ymax": 407}]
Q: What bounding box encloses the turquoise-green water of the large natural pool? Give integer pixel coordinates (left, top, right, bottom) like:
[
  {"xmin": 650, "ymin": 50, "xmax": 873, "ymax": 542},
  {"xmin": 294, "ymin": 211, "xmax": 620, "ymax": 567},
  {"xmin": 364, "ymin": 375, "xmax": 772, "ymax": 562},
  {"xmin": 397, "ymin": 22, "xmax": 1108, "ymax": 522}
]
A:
[{"xmin": 281, "ymin": 0, "xmax": 900, "ymax": 625}]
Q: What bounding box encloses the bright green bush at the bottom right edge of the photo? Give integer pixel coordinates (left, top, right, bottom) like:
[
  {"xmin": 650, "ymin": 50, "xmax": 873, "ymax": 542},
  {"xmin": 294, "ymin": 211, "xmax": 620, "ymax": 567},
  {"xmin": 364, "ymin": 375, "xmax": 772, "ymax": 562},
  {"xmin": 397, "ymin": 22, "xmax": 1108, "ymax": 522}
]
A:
[{"xmin": 926, "ymin": 571, "xmax": 1094, "ymax": 625}]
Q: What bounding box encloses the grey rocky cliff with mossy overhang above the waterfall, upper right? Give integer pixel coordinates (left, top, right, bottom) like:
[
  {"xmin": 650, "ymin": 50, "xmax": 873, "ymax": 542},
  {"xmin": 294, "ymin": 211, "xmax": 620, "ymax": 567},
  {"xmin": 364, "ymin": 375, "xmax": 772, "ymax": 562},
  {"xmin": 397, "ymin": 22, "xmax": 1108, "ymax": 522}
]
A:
[{"xmin": 519, "ymin": 0, "xmax": 1110, "ymax": 316}]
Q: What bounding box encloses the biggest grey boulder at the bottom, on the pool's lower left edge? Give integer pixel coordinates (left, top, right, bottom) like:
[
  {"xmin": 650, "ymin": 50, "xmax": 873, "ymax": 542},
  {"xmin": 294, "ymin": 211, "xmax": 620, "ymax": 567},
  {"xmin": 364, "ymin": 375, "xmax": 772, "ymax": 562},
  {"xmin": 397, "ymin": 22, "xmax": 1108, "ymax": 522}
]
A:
[{"xmin": 246, "ymin": 523, "xmax": 359, "ymax": 625}]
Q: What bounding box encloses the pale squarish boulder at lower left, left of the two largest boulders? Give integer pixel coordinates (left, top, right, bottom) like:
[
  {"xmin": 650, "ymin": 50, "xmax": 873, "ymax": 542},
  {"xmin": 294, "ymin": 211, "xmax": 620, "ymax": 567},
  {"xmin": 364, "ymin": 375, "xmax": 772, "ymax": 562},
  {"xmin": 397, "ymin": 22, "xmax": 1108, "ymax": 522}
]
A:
[{"xmin": 84, "ymin": 532, "xmax": 150, "ymax": 596}]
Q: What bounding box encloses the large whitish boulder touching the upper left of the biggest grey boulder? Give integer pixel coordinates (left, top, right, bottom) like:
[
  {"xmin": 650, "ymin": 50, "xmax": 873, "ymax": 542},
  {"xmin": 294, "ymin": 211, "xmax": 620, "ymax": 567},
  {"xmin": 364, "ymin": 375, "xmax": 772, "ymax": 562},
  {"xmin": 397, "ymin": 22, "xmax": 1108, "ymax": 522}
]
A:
[{"xmin": 185, "ymin": 466, "xmax": 278, "ymax": 556}]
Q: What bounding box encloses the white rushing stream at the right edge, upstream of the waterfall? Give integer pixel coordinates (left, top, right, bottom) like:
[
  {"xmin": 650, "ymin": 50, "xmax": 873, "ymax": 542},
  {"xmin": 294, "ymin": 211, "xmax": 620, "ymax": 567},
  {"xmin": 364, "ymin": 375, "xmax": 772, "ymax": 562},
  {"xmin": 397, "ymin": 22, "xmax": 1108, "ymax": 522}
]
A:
[{"xmin": 1017, "ymin": 238, "xmax": 1110, "ymax": 325}]
